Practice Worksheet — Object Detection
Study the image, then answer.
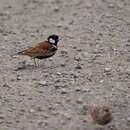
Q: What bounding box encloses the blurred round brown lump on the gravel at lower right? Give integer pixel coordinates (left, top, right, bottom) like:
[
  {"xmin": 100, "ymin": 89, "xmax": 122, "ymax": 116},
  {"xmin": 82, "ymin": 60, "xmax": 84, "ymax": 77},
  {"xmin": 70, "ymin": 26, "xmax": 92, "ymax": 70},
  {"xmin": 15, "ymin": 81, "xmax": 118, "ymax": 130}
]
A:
[{"xmin": 90, "ymin": 105, "xmax": 112, "ymax": 125}]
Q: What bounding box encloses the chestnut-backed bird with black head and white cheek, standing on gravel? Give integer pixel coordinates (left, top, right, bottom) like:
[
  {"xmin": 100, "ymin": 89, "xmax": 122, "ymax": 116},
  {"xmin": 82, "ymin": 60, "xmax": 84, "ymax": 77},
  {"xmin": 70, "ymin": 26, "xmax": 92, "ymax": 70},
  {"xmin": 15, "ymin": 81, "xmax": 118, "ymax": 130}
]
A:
[{"xmin": 16, "ymin": 34, "xmax": 61, "ymax": 66}]
